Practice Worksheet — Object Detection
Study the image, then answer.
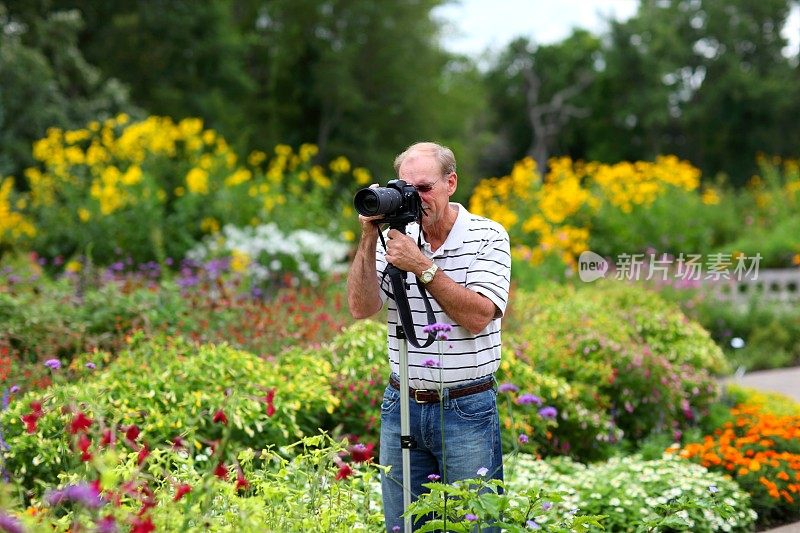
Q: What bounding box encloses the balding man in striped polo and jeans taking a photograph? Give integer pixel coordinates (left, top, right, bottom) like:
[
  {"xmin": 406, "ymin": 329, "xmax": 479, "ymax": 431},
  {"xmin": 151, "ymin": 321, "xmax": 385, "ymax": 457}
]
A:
[{"xmin": 347, "ymin": 142, "xmax": 511, "ymax": 531}]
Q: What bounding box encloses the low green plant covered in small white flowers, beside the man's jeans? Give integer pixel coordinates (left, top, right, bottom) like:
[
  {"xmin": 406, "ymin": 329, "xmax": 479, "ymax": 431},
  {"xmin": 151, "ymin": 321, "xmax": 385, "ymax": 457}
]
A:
[{"xmin": 506, "ymin": 455, "xmax": 756, "ymax": 532}]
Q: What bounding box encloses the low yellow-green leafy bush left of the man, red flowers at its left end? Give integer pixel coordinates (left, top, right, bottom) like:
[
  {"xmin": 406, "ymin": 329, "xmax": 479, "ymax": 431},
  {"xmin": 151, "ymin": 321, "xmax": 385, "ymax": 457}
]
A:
[{"xmin": 0, "ymin": 335, "xmax": 338, "ymax": 489}]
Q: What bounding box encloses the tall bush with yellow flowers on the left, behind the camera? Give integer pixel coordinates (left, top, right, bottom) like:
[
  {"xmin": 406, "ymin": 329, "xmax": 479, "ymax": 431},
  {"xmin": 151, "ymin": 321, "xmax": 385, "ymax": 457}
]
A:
[{"xmin": 20, "ymin": 114, "xmax": 362, "ymax": 265}]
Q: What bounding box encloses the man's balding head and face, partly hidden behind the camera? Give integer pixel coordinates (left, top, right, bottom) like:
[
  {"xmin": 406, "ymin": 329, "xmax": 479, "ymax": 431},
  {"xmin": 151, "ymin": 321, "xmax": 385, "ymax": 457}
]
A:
[{"xmin": 398, "ymin": 153, "xmax": 456, "ymax": 227}]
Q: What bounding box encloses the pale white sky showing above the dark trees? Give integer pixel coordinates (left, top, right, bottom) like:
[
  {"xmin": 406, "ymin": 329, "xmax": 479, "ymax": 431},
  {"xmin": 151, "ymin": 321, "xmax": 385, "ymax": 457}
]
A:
[{"xmin": 434, "ymin": 0, "xmax": 800, "ymax": 58}]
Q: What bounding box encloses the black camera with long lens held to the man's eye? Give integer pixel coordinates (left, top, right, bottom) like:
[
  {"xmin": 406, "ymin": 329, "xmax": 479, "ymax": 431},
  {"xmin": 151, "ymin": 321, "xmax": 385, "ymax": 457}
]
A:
[{"xmin": 353, "ymin": 180, "xmax": 422, "ymax": 226}]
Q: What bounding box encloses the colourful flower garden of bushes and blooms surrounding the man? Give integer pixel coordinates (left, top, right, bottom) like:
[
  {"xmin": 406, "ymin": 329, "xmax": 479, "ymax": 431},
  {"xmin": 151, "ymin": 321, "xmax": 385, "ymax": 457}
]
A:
[{"xmin": 0, "ymin": 114, "xmax": 800, "ymax": 532}]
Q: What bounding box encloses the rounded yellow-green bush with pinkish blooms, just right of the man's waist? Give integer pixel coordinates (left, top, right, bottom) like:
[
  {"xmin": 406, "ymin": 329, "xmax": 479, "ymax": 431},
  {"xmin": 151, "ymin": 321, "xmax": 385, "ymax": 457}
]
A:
[{"xmin": 506, "ymin": 283, "xmax": 726, "ymax": 441}]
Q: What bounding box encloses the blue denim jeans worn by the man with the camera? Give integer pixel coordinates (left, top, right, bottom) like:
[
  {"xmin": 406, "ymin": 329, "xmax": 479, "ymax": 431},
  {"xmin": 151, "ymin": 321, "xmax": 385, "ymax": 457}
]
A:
[{"xmin": 380, "ymin": 376, "xmax": 503, "ymax": 531}]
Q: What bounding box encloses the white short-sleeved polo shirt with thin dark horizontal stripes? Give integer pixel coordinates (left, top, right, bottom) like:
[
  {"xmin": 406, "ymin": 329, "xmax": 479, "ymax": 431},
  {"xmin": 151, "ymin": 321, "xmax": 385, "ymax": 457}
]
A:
[{"xmin": 376, "ymin": 203, "xmax": 511, "ymax": 389}]
